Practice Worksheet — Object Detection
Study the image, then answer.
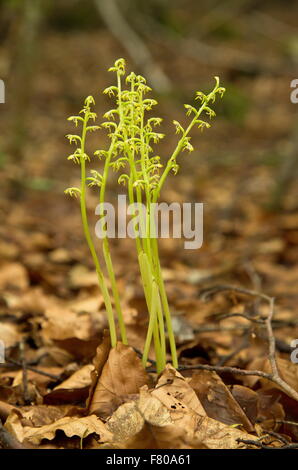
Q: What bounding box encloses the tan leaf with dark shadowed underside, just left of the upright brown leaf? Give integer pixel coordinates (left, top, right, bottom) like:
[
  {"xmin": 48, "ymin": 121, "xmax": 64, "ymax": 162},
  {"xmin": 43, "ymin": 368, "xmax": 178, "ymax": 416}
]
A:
[{"xmin": 43, "ymin": 364, "xmax": 94, "ymax": 405}]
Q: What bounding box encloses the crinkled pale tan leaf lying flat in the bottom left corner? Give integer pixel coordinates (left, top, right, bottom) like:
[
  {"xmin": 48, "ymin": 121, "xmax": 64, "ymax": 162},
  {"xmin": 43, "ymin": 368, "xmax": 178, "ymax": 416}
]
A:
[{"xmin": 5, "ymin": 412, "xmax": 112, "ymax": 445}]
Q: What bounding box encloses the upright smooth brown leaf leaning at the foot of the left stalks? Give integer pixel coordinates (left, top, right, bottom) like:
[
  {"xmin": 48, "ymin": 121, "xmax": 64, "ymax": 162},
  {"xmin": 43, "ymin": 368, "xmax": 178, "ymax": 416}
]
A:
[{"xmin": 89, "ymin": 342, "xmax": 148, "ymax": 417}]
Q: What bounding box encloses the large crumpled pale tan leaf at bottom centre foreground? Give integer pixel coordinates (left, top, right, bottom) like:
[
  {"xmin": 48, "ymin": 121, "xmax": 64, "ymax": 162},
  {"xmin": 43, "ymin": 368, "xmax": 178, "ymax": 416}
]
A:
[{"xmin": 107, "ymin": 387, "xmax": 256, "ymax": 449}]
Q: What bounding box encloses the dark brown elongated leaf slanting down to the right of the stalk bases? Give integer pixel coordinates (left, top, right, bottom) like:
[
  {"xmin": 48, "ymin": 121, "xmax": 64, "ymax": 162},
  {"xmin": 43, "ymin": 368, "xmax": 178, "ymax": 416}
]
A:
[{"xmin": 189, "ymin": 370, "xmax": 254, "ymax": 432}]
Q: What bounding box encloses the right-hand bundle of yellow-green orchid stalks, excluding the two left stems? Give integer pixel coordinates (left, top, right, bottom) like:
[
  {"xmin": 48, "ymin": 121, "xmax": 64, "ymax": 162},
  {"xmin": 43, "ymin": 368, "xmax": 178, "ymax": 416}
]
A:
[{"xmin": 105, "ymin": 59, "xmax": 225, "ymax": 370}]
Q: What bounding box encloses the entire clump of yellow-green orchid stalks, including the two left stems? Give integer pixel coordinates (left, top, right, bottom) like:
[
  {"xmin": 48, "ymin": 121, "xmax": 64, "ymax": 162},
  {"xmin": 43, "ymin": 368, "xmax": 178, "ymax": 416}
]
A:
[{"xmin": 64, "ymin": 59, "xmax": 225, "ymax": 372}]
